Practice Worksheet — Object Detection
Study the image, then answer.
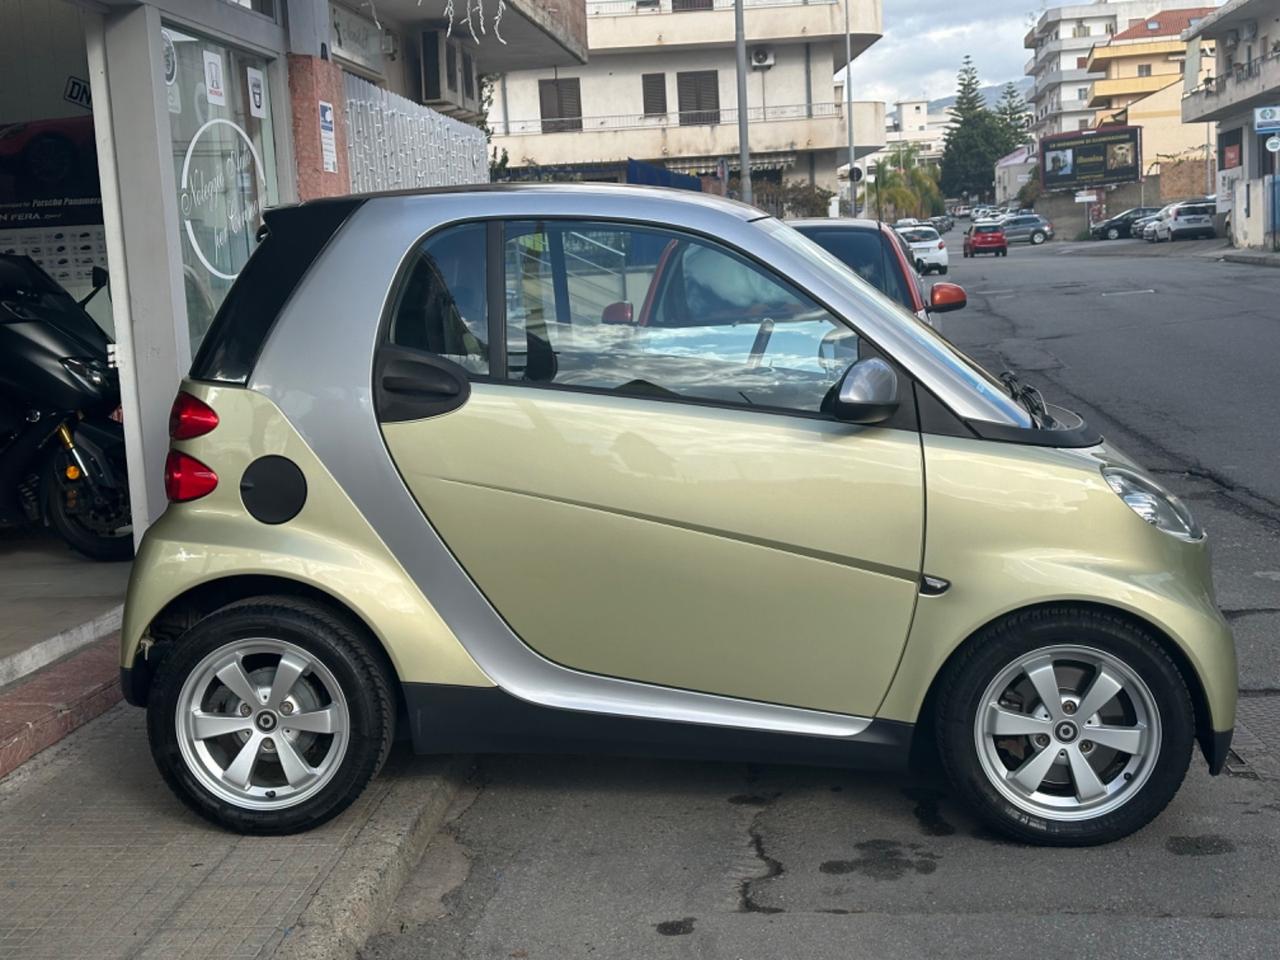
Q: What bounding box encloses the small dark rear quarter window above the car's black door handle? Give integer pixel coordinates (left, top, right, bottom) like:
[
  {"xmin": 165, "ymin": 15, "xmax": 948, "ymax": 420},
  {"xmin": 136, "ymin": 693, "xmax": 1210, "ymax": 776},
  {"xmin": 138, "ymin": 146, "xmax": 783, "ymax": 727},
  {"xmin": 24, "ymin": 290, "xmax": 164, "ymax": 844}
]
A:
[{"xmin": 389, "ymin": 223, "xmax": 489, "ymax": 375}]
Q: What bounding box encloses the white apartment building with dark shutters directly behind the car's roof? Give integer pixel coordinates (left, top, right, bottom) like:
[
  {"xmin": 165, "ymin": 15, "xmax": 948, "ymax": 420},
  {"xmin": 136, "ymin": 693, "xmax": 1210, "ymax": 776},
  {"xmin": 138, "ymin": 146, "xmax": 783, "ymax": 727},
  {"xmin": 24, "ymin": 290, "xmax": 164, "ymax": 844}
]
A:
[{"xmin": 489, "ymin": 0, "xmax": 884, "ymax": 191}]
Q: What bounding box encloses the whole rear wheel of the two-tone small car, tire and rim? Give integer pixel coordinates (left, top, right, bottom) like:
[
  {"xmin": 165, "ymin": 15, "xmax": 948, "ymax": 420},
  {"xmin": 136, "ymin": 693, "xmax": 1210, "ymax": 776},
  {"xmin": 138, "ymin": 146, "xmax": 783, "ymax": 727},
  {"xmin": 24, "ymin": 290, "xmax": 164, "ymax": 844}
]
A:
[{"xmin": 147, "ymin": 596, "xmax": 394, "ymax": 833}]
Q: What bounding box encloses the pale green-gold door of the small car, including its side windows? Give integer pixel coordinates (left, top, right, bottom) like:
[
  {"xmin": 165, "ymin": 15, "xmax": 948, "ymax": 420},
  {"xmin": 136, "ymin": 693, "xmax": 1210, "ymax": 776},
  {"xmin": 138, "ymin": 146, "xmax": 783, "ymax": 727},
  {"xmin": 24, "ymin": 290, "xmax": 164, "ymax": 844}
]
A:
[{"xmin": 381, "ymin": 221, "xmax": 924, "ymax": 714}]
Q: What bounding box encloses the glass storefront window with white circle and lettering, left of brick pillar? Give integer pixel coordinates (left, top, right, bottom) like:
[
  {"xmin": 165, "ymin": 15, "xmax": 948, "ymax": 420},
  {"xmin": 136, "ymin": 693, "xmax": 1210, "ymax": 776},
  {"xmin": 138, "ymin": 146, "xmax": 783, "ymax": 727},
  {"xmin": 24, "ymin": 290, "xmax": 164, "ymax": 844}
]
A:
[{"xmin": 161, "ymin": 26, "xmax": 279, "ymax": 353}]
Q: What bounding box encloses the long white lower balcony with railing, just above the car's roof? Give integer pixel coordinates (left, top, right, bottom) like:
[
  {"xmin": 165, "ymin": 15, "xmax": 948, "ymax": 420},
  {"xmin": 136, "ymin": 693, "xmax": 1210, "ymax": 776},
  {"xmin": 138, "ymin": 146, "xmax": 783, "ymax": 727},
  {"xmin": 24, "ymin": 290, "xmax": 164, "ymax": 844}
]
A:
[{"xmin": 493, "ymin": 101, "xmax": 884, "ymax": 166}]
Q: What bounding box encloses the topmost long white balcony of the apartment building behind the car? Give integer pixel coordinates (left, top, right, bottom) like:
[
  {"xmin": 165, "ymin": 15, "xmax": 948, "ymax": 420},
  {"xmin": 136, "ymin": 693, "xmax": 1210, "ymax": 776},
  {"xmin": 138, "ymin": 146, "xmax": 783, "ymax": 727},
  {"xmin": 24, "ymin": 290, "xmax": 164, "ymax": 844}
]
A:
[{"xmin": 586, "ymin": 0, "xmax": 883, "ymax": 56}]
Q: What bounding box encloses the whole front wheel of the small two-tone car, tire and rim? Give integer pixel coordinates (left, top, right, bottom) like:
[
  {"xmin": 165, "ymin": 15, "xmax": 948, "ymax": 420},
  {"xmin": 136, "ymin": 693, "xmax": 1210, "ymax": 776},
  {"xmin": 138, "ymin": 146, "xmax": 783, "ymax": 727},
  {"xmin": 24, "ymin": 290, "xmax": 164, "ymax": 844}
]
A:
[{"xmin": 937, "ymin": 608, "xmax": 1196, "ymax": 846}]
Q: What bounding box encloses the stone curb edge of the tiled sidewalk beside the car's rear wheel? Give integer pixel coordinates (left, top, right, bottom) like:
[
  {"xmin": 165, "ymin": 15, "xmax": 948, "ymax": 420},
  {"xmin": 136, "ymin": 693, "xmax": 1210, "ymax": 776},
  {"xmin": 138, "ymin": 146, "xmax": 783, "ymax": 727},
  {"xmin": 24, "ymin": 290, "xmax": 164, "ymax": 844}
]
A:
[{"xmin": 271, "ymin": 756, "xmax": 471, "ymax": 960}]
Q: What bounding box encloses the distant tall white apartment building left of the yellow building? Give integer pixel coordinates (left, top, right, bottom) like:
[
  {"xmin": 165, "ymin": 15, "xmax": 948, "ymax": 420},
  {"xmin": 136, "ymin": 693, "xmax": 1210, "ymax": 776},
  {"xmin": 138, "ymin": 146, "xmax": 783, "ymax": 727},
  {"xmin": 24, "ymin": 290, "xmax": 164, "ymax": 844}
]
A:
[{"xmin": 1023, "ymin": 0, "xmax": 1172, "ymax": 140}]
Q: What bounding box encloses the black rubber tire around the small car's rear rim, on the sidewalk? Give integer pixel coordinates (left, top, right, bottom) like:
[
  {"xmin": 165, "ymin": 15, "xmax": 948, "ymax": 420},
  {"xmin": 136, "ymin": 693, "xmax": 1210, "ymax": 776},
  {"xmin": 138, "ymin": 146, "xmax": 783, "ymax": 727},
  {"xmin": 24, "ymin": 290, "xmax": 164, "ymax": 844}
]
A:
[{"xmin": 147, "ymin": 596, "xmax": 396, "ymax": 835}]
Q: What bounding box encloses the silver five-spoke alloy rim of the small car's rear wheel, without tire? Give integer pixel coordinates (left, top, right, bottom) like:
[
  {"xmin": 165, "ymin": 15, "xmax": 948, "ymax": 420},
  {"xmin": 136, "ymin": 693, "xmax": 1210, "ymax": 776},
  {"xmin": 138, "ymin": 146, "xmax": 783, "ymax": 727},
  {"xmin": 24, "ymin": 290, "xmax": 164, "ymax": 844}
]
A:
[{"xmin": 174, "ymin": 637, "xmax": 351, "ymax": 810}]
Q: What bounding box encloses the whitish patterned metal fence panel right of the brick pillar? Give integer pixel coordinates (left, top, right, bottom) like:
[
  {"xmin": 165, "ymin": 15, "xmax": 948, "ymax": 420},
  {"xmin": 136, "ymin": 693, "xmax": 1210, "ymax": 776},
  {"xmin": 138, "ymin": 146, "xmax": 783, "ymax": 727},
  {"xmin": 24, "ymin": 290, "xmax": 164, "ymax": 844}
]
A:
[{"xmin": 344, "ymin": 73, "xmax": 489, "ymax": 193}]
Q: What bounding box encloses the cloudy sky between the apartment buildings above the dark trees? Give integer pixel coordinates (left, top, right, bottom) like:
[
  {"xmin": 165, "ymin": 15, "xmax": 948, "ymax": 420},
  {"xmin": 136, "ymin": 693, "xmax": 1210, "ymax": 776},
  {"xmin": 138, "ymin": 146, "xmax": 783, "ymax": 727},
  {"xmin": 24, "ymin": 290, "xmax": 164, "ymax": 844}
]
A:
[{"xmin": 852, "ymin": 0, "xmax": 1041, "ymax": 109}]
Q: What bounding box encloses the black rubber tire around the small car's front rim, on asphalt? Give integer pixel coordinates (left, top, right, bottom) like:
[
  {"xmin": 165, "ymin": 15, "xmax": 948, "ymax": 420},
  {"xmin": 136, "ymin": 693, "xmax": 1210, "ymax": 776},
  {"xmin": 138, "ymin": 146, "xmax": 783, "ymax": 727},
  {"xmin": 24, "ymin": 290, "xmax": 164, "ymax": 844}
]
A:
[{"xmin": 936, "ymin": 607, "xmax": 1196, "ymax": 846}]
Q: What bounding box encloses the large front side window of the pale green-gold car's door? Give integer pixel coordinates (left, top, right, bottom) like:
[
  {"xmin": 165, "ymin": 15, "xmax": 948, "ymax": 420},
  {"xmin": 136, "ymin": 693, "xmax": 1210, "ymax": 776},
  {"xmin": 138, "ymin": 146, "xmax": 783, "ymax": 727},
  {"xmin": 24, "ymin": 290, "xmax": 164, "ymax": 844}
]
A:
[{"xmin": 503, "ymin": 221, "xmax": 858, "ymax": 413}]
